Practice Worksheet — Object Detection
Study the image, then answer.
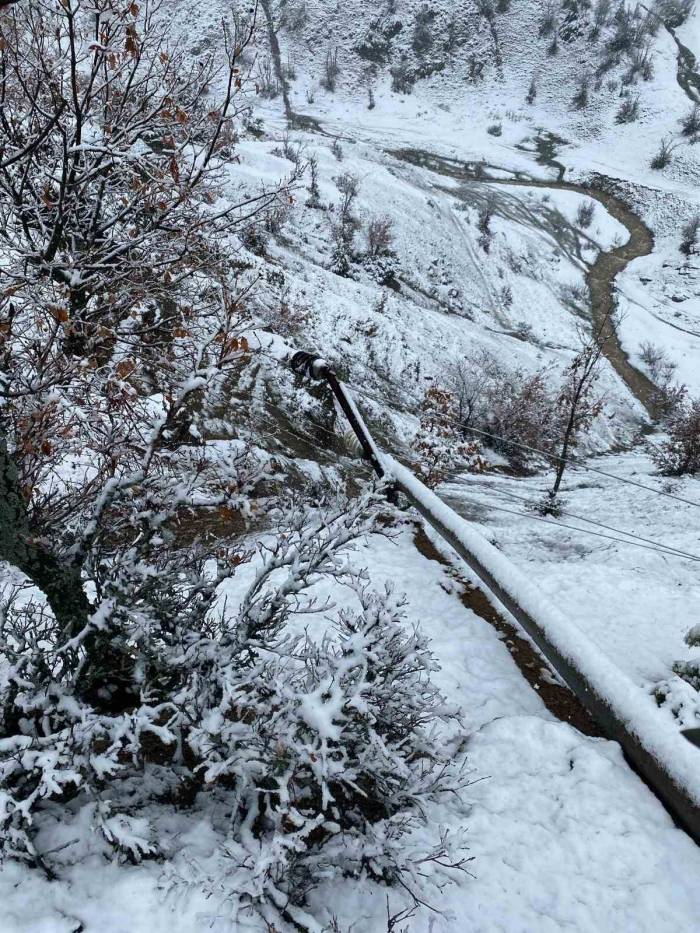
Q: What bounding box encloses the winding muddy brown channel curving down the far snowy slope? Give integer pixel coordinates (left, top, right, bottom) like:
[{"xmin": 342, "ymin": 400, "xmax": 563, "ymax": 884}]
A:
[{"xmin": 390, "ymin": 143, "xmax": 657, "ymax": 418}]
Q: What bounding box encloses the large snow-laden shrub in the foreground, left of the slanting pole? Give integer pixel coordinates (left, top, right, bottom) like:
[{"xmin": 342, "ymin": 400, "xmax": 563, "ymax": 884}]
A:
[{"xmin": 0, "ymin": 493, "xmax": 470, "ymax": 919}]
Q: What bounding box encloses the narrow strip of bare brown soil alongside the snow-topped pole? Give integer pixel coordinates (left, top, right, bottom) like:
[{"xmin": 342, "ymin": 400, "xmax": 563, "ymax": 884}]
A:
[{"xmin": 414, "ymin": 525, "xmax": 603, "ymax": 736}]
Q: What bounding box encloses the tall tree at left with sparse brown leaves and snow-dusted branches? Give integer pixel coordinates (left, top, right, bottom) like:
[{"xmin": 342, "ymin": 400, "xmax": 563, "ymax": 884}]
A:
[{"xmin": 0, "ymin": 0, "xmax": 292, "ymax": 708}]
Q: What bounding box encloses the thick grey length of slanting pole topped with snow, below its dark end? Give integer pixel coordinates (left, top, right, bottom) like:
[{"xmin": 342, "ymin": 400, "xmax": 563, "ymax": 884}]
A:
[{"xmin": 381, "ymin": 455, "xmax": 700, "ymax": 843}]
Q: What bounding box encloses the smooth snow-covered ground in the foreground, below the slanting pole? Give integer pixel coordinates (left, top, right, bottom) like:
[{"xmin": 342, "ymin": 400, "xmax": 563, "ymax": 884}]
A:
[{"xmin": 0, "ymin": 526, "xmax": 700, "ymax": 933}]
